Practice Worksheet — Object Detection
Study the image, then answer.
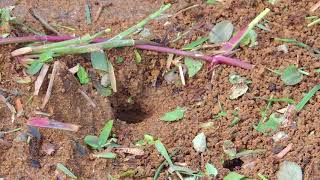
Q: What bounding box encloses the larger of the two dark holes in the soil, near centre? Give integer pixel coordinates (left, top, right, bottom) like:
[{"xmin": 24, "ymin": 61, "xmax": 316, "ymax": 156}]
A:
[{"xmin": 116, "ymin": 104, "xmax": 147, "ymax": 124}]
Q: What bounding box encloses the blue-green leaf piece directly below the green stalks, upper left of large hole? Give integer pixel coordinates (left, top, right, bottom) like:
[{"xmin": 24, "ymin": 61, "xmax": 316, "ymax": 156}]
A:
[{"xmin": 90, "ymin": 50, "xmax": 109, "ymax": 72}]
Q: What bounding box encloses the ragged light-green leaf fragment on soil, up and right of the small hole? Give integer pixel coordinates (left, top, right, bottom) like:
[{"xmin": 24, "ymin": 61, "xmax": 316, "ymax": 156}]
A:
[{"xmin": 254, "ymin": 113, "xmax": 284, "ymax": 133}]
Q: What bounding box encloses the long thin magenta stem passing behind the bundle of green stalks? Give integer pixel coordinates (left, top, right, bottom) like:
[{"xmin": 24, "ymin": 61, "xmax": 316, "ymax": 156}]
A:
[{"xmin": 0, "ymin": 35, "xmax": 253, "ymax": 69}]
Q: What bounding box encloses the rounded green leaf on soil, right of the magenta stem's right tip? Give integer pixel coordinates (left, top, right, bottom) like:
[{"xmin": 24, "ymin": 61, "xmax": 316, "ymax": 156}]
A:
[{"xmin": 281, "ymin": 65, "xmax": 303, "ymax": 86}]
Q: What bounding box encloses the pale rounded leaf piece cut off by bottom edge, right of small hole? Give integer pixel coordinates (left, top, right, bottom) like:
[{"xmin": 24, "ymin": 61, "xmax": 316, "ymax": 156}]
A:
[{"xmin": 277, "ymin": 161, "xmax": 303, "ymax": 180}]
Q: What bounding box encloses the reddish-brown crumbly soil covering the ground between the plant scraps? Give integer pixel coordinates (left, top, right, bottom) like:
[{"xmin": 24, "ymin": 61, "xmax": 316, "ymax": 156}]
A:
[{"xmin": 0, "ymin": 0, "xmax": 320, "ymax": 179}]
